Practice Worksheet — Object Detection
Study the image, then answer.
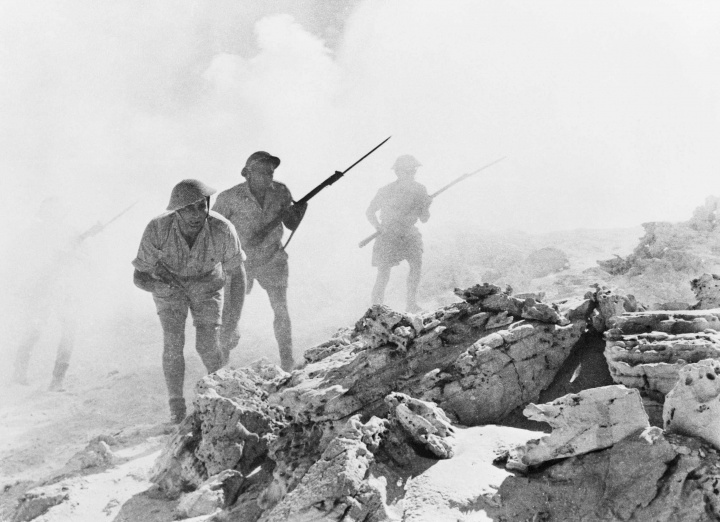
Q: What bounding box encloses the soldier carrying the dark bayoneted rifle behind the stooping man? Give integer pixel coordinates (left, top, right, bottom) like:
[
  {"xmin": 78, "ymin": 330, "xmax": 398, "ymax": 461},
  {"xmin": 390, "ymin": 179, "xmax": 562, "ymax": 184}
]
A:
[{"xmin": 213, "ymin": 151, "xmax": 307, "ymax": 371}]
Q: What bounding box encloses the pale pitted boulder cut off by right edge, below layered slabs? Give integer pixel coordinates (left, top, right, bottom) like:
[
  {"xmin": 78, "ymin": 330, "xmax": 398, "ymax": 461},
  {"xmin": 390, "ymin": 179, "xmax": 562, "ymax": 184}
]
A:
[{"xmin": 663, "ymin": 359, "xmax": 720, "ymax": 448}]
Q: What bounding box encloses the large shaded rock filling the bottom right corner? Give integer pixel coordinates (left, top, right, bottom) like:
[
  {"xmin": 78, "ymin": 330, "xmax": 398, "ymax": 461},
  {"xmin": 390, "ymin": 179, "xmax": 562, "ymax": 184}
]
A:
[{"xmin": 486, "ymin": 427, "xmax": 720, "ymax": 522}]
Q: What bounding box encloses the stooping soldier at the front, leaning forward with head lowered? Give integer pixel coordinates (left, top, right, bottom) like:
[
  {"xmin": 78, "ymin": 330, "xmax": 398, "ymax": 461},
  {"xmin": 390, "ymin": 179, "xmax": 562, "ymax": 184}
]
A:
[{"xmin": 132, "ymin": 179, "xmax": 245, "ymax": 423}]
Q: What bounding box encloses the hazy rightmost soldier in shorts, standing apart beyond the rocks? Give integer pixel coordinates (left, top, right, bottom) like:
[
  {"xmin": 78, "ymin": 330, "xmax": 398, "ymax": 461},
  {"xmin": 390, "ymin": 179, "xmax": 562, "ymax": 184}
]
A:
[{"xmin": 365, "ymin": 154, "xmax": 431, "ymax": 312}]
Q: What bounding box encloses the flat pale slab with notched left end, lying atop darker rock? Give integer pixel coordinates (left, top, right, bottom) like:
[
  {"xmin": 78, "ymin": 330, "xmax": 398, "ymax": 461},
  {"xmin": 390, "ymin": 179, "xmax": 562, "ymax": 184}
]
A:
[{"xmin": 507, "ymin": 386, "xmax": 650, "ymax": 471}]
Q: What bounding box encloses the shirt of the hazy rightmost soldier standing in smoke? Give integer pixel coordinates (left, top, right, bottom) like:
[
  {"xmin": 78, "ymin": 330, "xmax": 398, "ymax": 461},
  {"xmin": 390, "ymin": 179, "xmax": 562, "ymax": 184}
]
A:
[{"xmin": 368, "ymin": 180, "xmax": 431, "ymax": 231}]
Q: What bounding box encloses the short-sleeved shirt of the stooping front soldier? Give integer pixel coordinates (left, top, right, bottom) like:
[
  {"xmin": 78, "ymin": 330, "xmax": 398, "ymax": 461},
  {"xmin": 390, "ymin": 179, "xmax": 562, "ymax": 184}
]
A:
[{"xmin": 132, "ymin": 211, "xmax": 244, "ymax": 278}]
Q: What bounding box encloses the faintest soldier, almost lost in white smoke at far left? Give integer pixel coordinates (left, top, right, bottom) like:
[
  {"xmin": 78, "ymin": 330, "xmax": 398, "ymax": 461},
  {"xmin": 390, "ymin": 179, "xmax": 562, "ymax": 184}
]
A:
[{"xmin": 13, "ymin": 198, "xmax": 102, "ymax": 391}]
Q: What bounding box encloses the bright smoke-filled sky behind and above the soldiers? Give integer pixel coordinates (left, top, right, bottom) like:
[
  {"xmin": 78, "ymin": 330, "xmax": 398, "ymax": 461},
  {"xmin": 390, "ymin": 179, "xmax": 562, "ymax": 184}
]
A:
[{"xmin": 0, "ymin": 0, "xmax": 720, "ymax": 372}]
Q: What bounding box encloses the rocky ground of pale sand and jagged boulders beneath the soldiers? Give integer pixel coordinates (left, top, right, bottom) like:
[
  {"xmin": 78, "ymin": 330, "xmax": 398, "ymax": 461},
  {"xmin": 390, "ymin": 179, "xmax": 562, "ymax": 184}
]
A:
[{"xmin": 0, "ymin": 200, "xmax": 720, "ymax": 522}]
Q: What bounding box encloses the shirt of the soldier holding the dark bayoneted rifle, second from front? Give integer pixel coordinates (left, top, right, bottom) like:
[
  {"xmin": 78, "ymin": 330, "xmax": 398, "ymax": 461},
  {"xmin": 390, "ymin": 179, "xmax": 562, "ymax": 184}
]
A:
[{"xmin": 213, "ymin": 181, "xmax": 292, "ymax": 281}]
